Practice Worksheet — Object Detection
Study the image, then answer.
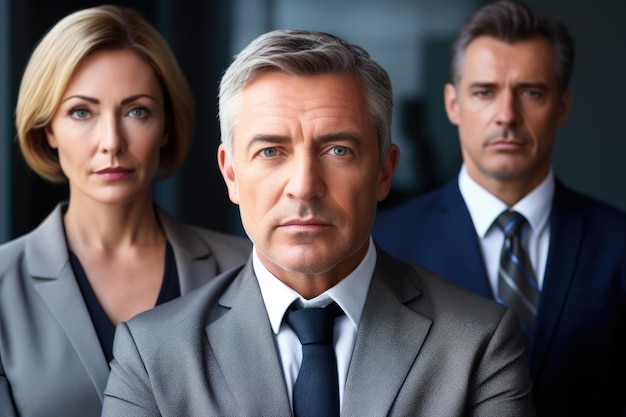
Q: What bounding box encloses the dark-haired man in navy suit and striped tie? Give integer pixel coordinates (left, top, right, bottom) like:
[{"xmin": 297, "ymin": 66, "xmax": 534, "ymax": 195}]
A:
[{"xmin": 372, "ymin": 1, "xmax": 626, "ymax": 416}]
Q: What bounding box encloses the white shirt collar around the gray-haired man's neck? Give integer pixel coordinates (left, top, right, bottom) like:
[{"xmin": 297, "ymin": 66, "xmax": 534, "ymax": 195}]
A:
[{"xmin": 252, "ymin": 236, "xmax": 376, "ymax": 334}]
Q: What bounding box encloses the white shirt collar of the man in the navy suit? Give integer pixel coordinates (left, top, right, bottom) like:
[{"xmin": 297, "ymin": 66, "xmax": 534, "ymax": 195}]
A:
[{"xmin": 459, "ymin": 164, "xmax": 555, "ymax": 237}]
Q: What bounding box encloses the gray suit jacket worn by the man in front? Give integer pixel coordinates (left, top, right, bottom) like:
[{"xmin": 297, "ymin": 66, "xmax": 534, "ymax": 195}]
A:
[{"xmin": 103, "ymin": 250, "xmax": 534, "ymax": 417}]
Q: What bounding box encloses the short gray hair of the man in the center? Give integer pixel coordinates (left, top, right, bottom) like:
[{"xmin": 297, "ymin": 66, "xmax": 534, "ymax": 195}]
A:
[{"xmin": 214, "ymin": 30, "xmax": 393, "ymax": 161}]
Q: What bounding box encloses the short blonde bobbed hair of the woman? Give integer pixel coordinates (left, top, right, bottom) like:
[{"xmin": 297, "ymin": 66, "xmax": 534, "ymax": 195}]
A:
[{"xmin": 15, "ymin": 5, "xmax": 194, "ymax": 182}]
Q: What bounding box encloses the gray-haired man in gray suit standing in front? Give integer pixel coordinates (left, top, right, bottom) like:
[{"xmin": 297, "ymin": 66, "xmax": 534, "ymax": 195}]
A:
[{"xmin": 103, "ymin": 31, "xmax": 534, "ymax": 417}]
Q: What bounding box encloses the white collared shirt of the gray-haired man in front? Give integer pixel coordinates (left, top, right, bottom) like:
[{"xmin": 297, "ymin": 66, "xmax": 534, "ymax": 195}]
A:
[{"xmin": 252, "ymin": 236, "xmax": 376, "ymax": 408}]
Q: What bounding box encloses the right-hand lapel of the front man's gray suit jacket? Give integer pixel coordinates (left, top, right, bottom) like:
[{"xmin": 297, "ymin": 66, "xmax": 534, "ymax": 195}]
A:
[{"xmin": 342, "ymin": 250, "xmax": 431, "ymax": 416}]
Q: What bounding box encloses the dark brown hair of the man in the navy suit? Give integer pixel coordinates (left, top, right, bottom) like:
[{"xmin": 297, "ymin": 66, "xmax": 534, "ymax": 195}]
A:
[{"xmin": 450, "ymin": 0, "xmax": 574, "ymax": 93}]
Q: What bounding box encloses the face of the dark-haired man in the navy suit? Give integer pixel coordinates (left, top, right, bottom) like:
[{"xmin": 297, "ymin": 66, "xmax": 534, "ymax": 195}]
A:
[{"xmin": 444, "ymin": 36, "xmax": 571, "ymax": 189}]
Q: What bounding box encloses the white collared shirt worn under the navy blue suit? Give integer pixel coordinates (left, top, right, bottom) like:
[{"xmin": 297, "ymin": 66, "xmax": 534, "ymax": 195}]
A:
[{"xmin": 459, "ymin": 164, "xmax": 555, "ymax": 294}]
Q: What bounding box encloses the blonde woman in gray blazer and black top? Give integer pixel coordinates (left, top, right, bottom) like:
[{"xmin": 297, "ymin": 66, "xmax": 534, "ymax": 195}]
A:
[{"xmin": 0, "ymin": 6, "xmax": 250, "ymax": 417}]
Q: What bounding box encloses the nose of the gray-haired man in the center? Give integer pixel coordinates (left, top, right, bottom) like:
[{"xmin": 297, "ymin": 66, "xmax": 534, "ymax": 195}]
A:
[{"xmin": 285, "ymin": 153, "xmax": 326, "ymax": 201}]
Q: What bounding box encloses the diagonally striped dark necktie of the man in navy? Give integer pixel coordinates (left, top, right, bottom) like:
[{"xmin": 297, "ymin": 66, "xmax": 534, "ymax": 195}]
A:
[{"xmin": 496, "ymin": 210, "xmax": 539, "ymax": 339}]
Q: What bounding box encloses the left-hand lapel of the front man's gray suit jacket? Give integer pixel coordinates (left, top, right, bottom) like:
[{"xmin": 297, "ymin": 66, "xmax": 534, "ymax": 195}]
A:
[{"xmin": 206, "ymin": 261, "xmax": 291, "ymax": 416}]
